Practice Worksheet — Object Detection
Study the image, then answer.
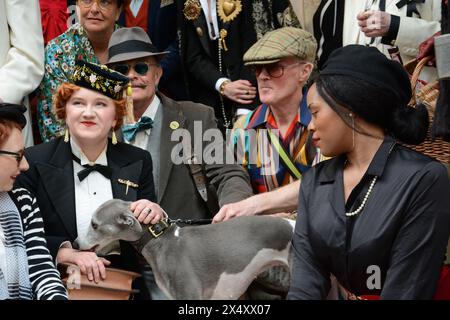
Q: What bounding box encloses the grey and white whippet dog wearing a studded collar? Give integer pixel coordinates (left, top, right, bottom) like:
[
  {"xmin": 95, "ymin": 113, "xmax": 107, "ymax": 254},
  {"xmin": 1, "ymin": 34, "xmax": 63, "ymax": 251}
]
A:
[{"xmin": 76, "ymin": 199, "xmax": 293, "ymax": 300}]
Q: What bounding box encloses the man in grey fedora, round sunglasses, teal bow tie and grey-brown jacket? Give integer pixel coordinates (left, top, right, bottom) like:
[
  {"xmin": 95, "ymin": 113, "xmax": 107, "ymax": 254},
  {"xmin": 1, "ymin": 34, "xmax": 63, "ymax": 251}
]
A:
[{"xmin": 108, "ymin": 27, "xmax": 253, "ymax": 298}]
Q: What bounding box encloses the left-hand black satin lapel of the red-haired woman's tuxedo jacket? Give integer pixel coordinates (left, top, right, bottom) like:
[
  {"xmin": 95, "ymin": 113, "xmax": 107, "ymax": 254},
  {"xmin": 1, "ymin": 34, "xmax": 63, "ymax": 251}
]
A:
[{"xmin": 36, "ymin": 139, "xmax": 77, "ymax": 239}]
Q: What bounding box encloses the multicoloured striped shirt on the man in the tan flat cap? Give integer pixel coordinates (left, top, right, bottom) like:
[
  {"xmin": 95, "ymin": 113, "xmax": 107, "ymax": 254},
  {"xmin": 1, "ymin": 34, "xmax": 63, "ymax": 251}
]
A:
[{"xmin": 233, "ymin": 94, "xmax": 322, "ymax": 193}]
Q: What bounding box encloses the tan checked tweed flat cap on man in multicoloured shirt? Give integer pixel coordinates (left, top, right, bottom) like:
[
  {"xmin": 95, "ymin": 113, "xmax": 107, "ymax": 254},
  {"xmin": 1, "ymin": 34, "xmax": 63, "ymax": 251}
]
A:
[{"xmin": 244, "ymin": 27, "xmax": 317, "ymax": 65}]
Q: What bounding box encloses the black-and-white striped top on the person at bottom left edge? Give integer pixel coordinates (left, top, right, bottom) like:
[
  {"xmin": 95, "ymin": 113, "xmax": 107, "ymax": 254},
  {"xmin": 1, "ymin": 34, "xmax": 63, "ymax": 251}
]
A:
[{"xmin": 2, "ymin": 189, "xmax": 67, "ymax": 300}]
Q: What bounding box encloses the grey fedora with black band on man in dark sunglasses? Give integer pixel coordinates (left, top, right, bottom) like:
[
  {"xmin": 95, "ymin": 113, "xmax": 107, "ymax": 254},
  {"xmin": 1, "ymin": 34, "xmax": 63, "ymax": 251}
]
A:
[{"xmin": 106, "ymin": 27, "xmax": 169, "ymax": 64}]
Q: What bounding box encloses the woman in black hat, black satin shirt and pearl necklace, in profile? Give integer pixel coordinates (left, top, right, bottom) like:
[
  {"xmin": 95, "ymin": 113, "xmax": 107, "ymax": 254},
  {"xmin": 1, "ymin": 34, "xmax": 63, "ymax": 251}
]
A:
[{"xmin": 288, "ymin": 45, "xmax": 450, "ymax": 299}]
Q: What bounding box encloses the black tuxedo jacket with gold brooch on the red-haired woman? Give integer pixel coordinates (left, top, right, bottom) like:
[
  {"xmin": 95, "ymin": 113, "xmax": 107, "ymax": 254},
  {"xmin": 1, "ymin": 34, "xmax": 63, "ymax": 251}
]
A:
[{"xmin": 15, "ymin": 138, "xmax": 156, "ymax": 271}]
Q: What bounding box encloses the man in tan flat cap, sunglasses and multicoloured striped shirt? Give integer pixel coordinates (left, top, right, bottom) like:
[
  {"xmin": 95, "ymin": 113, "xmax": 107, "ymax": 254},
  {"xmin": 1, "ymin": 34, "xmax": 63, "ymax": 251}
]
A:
[{"xmin": 214, "ymin": 27, "xmax": 321, "ymax": 222}]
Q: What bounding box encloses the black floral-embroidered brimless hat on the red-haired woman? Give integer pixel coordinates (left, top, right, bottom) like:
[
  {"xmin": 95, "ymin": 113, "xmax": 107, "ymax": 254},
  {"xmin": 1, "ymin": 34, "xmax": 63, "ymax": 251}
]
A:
[{"xmin": 71, "ymin": 60, "xmax": 130, "ymax": 100}]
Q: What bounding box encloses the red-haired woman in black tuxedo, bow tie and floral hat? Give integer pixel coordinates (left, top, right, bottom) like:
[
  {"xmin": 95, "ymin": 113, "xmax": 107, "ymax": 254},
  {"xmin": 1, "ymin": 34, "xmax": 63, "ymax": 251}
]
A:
[{"xmin": 17, "ymin": 61, "xmax": 164, "ymax": 298}]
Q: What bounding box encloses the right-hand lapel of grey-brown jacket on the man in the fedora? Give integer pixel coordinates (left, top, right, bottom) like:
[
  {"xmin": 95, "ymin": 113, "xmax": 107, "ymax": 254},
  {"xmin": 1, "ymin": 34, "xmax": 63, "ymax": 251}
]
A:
[{"xmin": 158, "ymin": 94, "xmax": 186, "ymax": 202}]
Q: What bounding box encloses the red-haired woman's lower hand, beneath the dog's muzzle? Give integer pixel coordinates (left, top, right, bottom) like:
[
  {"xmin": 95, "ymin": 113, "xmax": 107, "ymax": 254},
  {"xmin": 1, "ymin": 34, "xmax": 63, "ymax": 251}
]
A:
[{"xmin": 56, "ymin": 248, "xmax": 111, "ymax": 283}]
